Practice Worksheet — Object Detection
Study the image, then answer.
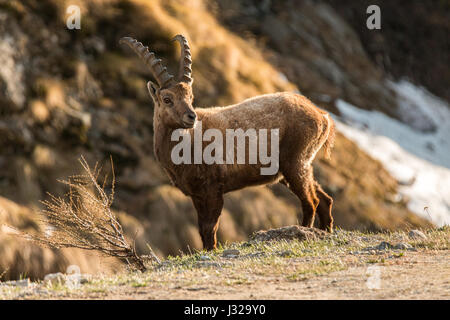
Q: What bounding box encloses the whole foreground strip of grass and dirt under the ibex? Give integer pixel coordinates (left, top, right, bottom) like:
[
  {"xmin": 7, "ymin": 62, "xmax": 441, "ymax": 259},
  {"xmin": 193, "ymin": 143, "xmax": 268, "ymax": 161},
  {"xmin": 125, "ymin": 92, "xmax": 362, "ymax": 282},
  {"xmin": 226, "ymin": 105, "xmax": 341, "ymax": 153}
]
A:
[{"xmin": 0, "ymin": 226, "xmax": 450, "ymax": 299}]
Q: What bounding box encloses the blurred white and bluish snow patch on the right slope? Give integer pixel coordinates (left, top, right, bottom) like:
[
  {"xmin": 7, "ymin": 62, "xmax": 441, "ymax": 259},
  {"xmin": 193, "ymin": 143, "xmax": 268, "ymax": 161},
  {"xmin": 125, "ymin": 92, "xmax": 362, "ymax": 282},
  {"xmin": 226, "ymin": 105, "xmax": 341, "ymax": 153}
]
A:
[{"xmin": 334, "ymin": 81, "xmax": 450, "ymax": 226}]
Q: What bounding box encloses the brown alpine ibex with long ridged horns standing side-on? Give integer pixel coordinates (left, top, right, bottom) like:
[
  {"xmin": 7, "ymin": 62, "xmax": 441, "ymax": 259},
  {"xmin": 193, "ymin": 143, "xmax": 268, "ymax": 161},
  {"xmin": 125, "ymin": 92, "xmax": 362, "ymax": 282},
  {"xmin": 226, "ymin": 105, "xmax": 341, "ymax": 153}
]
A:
[{"xmin": 120, "ymin": 35, "xmax": 334, "ymax": 250}]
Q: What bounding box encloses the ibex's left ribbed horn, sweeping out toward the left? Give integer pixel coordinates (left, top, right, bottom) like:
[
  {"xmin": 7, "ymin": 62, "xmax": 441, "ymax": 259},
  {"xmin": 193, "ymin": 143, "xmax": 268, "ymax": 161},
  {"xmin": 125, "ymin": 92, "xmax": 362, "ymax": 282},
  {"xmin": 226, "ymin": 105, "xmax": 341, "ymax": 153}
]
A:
[{"xmin": 119, "ymin": 37, "xmax": 174, "ymax": 88}]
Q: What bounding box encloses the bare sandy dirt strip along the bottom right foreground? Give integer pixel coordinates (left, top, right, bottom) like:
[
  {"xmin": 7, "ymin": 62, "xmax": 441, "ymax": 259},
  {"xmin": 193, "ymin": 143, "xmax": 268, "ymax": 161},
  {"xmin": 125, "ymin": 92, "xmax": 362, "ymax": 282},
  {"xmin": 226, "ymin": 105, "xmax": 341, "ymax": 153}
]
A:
[{"xmin": 98, "ymin": 251, "xmax": 450, "ymax": 299}]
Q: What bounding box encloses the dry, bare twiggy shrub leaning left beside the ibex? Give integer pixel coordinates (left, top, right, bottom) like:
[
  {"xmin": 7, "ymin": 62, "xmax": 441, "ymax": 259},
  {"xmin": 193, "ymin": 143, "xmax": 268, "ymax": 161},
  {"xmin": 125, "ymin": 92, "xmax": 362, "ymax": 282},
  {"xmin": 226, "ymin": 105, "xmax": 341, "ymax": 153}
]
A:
[{"xmin": 10, "ymin": 157, "xmax": 158, "ymax": 271}]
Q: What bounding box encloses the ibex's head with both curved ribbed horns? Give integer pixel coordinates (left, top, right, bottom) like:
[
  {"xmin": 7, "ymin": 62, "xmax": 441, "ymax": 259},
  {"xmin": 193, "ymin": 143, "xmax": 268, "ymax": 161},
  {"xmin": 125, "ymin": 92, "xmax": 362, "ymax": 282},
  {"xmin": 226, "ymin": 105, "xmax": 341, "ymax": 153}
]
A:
[{"xmin": 120, "ymin": 35, "xmax": 197, "ymax": 128}]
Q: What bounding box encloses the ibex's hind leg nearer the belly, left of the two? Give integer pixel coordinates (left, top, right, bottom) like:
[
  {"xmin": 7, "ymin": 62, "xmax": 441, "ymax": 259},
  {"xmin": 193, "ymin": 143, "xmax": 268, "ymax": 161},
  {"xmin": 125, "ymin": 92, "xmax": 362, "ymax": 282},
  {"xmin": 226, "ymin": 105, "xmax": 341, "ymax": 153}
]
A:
[{"xmin": 283, "ymin": 166, "xmax": 319, "ymax": 228}]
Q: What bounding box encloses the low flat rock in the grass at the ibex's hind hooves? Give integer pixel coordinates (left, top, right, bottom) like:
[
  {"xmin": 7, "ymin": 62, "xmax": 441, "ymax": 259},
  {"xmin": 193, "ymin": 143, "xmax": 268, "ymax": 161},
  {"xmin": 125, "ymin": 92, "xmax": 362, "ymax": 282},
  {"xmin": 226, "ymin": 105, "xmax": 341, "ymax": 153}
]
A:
[{"xmin": 252, "ymin": 226, "xmax": 328, "ymax": 241}]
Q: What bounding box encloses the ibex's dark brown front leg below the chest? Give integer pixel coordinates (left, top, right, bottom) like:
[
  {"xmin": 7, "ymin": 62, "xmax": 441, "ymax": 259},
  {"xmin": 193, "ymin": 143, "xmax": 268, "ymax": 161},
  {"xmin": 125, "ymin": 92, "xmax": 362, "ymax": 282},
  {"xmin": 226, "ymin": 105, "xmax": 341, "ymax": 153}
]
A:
[{"xmin": 192, "ymin": 191, "xmax": 223, "ymax": 250}]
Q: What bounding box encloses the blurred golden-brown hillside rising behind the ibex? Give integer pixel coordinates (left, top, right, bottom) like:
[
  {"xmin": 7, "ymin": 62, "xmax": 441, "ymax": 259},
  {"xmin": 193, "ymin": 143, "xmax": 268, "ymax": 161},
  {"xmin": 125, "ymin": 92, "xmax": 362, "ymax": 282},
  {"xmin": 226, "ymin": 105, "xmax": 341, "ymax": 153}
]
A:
[{"xmin": 0, "ymin": 0, "xmax": 440, "ymax": 279}]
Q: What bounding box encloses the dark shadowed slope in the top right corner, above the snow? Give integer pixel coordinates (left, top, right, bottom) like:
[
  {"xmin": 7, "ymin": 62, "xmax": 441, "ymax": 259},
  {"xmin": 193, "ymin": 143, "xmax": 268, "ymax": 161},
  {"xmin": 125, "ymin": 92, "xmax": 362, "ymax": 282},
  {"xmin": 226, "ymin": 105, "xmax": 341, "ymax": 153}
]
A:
[{"xmin": 326, "ymin": 0, "xmax": 450, "ymax": 101}]
